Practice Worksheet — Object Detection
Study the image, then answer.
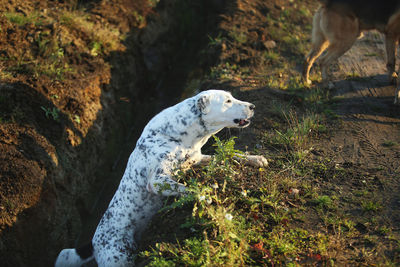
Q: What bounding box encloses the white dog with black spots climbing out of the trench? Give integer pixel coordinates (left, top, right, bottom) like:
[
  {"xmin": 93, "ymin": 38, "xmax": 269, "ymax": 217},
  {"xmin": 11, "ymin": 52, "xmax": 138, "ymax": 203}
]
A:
[{"xmin": 55, "ymin": 90, "xmax": 267, "ymax": 267}]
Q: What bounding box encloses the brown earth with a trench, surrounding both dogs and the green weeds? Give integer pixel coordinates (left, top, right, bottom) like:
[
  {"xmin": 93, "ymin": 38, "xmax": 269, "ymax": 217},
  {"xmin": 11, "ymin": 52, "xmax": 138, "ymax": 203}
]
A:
[{"xmin": 0, "ymin": 0, "xmax": 400, "ymax": 266}]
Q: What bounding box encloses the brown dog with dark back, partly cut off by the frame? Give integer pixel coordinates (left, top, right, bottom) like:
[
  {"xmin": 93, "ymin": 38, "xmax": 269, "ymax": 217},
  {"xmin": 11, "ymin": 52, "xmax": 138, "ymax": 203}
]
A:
[{"xmin": 303, "ymin": 0, "xmax": 400, "ymax": 103}]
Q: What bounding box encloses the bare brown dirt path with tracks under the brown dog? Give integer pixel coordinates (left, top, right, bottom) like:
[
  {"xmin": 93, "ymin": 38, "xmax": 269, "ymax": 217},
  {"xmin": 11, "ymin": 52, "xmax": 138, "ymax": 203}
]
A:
[{"xmin": 322, "ymin": 32, "xmax": 400, "ymax": 230}]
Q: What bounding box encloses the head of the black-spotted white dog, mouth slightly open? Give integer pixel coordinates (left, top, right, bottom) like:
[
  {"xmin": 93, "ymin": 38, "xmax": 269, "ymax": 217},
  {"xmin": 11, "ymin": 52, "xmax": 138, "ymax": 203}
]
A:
[{"xmin": 197, "ymin": 90, "xmax": 255, "ymax": 128}]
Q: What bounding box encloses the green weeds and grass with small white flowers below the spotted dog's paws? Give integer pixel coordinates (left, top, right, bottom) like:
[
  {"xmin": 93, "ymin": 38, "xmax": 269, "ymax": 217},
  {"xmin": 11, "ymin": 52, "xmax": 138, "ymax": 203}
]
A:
[{"xmin": 140, "ymin": 138, "xmax": 336, "ymax": 266}]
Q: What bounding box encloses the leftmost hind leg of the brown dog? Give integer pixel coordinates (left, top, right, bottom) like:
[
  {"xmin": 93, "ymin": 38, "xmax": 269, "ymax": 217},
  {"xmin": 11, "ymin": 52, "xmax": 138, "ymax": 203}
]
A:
[{"xmin": 302, "ymin": 8, "xmax": 329, "ymax": 84}]
